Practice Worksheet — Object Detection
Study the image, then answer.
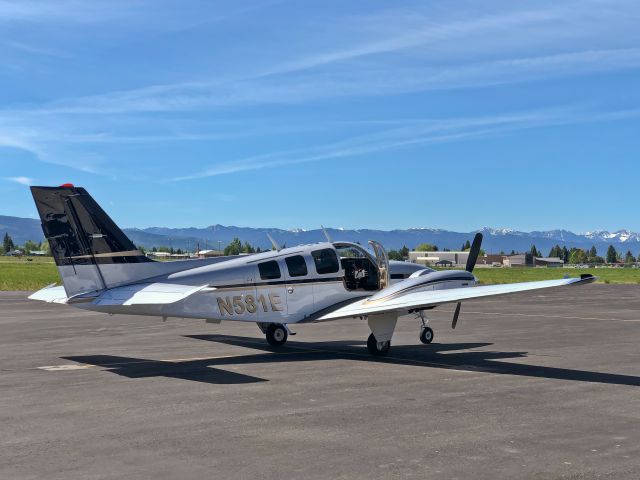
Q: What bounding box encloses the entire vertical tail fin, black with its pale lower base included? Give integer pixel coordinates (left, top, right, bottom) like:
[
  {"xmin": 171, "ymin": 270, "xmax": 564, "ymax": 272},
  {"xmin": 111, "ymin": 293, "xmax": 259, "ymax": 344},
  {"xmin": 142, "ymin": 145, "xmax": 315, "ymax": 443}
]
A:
[{"xmin": 31, "ymin": 185, "xmax": 155, "ymax": 297}]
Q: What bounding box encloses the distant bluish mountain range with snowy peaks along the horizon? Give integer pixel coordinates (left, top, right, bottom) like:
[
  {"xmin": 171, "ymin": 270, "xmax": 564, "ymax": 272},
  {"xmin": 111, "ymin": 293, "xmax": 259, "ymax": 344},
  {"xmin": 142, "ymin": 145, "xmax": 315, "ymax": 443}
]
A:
[{"xmin": 0, "ymin": 215, "xmax": 640, "ymax": 255}]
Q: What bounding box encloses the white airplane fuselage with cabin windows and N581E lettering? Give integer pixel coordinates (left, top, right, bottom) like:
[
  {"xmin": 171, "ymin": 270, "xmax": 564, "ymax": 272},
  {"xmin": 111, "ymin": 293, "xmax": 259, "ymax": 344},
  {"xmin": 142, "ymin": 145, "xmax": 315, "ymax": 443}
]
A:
[{"xmin": 76, "ymin": 242, "xmax": 475, "ymax": 323}]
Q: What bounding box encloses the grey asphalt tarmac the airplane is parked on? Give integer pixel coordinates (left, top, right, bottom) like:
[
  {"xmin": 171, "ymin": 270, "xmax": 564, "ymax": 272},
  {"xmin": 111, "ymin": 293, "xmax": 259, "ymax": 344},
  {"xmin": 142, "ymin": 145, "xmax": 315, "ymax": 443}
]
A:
[{"xmin": 0, "ymin": 285, "xmax": 640, "ymax": 480}]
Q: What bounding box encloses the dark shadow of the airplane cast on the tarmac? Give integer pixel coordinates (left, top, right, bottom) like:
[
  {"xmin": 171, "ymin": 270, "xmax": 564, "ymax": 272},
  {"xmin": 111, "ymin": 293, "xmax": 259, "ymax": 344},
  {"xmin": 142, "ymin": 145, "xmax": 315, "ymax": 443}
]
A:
[{"xmin": 62, "ymin": 335, "xmax": 640, "ymax": 386}]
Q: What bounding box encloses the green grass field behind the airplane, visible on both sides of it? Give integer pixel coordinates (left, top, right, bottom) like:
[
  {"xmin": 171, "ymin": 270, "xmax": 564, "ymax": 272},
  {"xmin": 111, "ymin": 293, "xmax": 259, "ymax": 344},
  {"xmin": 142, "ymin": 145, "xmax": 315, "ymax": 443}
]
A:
[{"xmin": 0, "ymin": 257, "xmax": 640, "ymax": 290}]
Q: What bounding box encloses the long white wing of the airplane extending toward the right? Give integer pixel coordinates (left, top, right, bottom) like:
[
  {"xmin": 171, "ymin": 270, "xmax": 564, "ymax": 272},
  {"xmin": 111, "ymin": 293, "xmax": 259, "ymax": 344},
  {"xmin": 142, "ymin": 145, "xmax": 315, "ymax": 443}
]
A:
[{"xmin": 312, "ymin": 275, "xmax": 596, "ymax": 321}]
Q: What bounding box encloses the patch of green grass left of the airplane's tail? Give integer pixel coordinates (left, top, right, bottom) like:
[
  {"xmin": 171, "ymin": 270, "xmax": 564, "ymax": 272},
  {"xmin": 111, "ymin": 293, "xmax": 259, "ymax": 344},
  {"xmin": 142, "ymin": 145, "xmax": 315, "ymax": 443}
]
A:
[{"xmin": 0, "ymin": 256, "xmax": 60, "ymax": 290}]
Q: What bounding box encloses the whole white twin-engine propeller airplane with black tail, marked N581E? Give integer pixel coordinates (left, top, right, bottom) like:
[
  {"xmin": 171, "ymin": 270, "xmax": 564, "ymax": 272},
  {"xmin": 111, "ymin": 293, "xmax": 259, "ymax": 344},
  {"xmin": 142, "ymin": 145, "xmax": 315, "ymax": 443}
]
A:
[{"xmin": 29, "ymin": 184, "xmax": 596, "ymax": 356}]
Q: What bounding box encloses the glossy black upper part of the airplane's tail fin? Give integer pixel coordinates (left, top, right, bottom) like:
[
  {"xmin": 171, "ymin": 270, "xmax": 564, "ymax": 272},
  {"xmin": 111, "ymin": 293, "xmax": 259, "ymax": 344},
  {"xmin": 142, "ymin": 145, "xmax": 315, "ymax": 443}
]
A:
[{"xmin": 31, "ymin": 186, "xmax": 152, "ymax": 266}]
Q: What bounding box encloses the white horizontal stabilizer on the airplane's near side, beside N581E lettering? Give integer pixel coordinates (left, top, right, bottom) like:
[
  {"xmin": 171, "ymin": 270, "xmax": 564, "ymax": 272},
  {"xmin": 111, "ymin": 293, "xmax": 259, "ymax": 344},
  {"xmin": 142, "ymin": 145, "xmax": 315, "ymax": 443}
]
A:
[{"xmin": 93, "ymin": 283, "xmax": 206, "ymax": 305}]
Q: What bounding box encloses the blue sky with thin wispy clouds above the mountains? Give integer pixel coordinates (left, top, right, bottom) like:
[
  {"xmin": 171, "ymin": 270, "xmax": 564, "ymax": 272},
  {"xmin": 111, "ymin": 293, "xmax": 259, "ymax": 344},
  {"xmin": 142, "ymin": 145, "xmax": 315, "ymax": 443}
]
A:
[{"xmin": 0, "ymin": 0, "xmax": 640, "ymax": 232}]
